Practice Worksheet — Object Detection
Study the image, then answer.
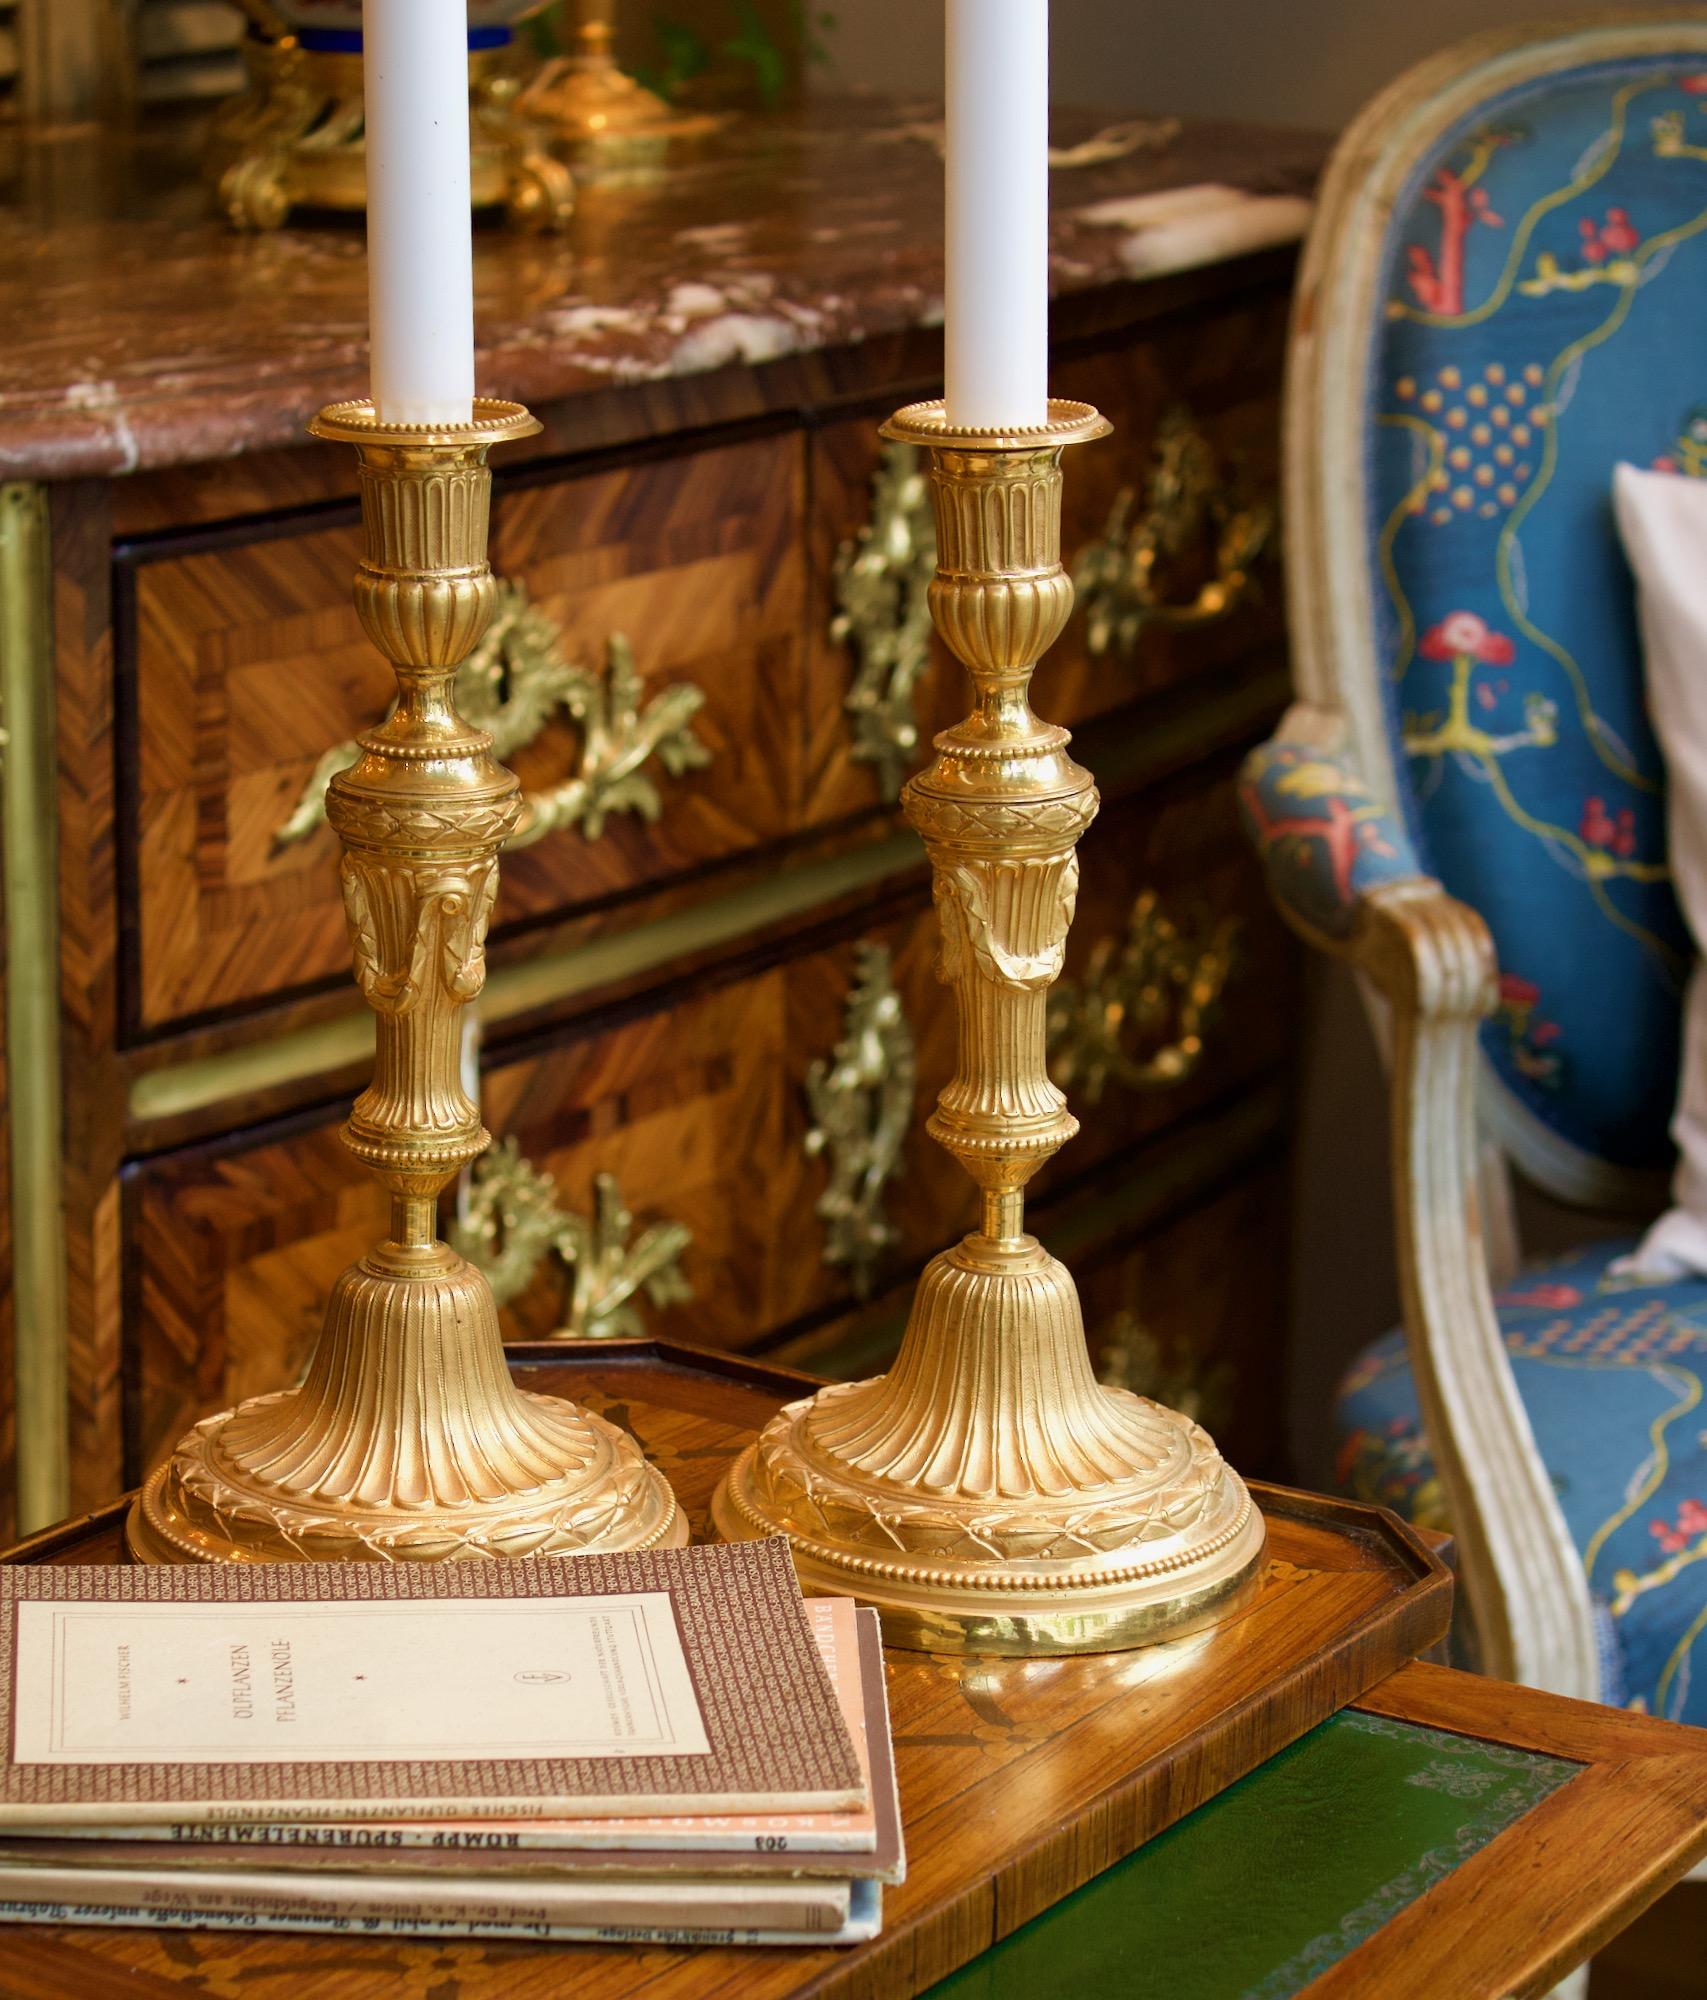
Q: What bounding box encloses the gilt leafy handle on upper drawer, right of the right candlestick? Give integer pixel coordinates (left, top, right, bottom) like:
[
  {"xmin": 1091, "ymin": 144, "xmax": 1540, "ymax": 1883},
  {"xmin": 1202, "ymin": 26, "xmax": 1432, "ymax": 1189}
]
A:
[{"xmin": 1073, "ymin": 406, "xmax": 1275, "ymax": 656}]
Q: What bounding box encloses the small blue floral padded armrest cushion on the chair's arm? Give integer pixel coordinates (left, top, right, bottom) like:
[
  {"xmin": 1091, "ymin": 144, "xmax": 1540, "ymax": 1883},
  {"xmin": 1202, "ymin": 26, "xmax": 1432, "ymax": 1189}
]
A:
[{"xmin": 1239, "ymin": 738, "xmax": 1421, "ymax": 938}]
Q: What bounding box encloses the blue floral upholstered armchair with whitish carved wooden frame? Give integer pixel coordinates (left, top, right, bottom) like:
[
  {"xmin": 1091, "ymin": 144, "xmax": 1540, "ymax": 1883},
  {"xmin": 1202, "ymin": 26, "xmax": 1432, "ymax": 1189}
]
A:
[{"xmin": 1243, "ymin": 10, "xmax": 1707, "ymax": 1722}]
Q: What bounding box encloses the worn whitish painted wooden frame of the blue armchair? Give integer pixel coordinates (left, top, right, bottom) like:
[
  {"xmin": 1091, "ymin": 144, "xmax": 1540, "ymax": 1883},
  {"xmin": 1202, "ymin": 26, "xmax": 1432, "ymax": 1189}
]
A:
[{"xmin": 1281, "ymin": 8, "xmax": 1707, "ymax": 1728}]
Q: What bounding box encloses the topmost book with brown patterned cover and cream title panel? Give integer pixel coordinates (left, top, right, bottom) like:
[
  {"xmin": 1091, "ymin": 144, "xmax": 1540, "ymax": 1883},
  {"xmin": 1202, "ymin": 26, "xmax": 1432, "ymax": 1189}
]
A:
[{"xmin": 0, "ymin": 1540, "xmax": 867, "ymax": 1828}]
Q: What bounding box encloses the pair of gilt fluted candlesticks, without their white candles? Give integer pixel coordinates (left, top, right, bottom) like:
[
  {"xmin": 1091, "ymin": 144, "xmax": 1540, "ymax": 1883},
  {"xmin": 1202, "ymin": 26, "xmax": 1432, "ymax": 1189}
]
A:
[{"xmin": 128, "ymin": 390, "xmax": 1263, "ymax": 1654}]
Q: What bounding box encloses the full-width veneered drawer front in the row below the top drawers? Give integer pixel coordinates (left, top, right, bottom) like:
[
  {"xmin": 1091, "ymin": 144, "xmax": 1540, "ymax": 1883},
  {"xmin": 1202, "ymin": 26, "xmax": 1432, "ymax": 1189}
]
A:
[{"xmin": 124, "ymin": 756, "xmax": 1291, "ymax": 1474}]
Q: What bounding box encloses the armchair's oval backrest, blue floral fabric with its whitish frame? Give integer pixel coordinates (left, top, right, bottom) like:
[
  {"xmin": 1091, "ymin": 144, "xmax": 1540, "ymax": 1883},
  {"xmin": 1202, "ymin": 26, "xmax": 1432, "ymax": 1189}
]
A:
[{"xmin": 1285, "ymin": 8, "xmax": 1707, "ymax": 1206}]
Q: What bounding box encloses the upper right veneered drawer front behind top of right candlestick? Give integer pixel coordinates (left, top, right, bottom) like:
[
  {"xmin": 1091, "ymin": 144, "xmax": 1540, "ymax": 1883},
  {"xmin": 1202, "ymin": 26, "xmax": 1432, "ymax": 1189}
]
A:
[{"xmin": 808, "ymin": 292, "xmax": 1287, "ymax": 814}]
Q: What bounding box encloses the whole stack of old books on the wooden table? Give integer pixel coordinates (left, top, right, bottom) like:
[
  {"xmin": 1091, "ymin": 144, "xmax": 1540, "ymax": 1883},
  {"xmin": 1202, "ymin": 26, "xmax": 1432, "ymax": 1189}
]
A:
[{"xmin": 0, "ymin": 1540, "xmax": 903, "ymax": 1944}]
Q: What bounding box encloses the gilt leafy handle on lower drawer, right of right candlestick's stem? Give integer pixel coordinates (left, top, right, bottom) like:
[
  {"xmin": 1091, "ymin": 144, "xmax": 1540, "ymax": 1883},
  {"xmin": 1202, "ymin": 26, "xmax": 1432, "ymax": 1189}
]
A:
[{"xmin": 1049, "ymin": 890, "xmax": 1239, "ymax": 1104}]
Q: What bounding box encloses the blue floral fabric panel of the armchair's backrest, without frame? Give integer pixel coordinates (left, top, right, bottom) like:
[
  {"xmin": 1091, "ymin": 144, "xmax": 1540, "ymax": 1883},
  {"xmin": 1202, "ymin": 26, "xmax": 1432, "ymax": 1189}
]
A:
[{"xmin": 1365, "ymin": 56, "xmax": 1707, "ymax": 1168}]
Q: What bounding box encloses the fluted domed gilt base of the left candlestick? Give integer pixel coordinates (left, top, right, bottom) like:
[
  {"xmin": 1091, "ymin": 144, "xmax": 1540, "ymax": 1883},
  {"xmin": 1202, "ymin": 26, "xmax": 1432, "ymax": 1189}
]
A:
[{"xmin": 126, "ymin": 1244, "xmax": 688, "ymax": 1562}]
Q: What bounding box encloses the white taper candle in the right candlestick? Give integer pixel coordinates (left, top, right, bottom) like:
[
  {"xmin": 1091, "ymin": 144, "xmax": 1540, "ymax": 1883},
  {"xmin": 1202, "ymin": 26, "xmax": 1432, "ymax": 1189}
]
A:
[{"xmin": 943, "ymin": 0, "xmax": 1049, "ymax": 430}]
